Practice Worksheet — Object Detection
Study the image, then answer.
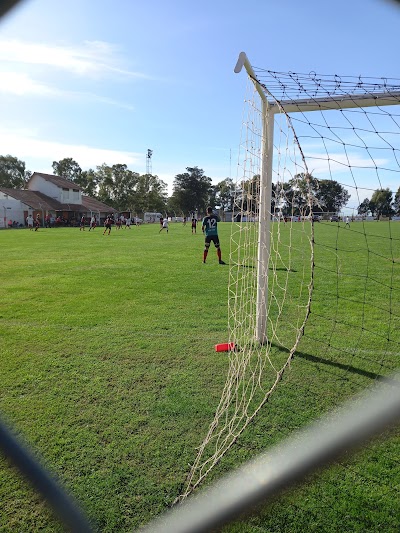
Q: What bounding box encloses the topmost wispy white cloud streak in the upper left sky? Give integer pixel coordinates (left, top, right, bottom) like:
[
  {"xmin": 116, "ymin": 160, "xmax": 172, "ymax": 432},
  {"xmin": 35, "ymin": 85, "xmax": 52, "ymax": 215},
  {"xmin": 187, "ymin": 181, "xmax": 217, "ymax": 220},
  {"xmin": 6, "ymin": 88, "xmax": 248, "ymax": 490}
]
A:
[{"xmin": 0, "ymin": 39, "xmax": 148, "ymax": 78}]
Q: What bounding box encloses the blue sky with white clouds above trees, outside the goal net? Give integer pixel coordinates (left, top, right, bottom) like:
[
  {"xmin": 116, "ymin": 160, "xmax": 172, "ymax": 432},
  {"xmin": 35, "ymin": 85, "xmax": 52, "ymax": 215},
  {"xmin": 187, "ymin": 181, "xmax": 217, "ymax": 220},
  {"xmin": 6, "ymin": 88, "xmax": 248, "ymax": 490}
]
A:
[{"xmin": 0, "ymin": 0, "xmax": 400, "ymax": 196}]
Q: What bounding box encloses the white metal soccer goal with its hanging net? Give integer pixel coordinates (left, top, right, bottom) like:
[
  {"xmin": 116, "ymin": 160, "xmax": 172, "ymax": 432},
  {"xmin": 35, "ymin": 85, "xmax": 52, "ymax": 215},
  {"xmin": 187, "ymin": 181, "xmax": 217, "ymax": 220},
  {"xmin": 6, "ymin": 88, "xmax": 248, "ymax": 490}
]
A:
[{"xmin": 181, "ymin": 53, "xmax": 400, "ymax": 499}]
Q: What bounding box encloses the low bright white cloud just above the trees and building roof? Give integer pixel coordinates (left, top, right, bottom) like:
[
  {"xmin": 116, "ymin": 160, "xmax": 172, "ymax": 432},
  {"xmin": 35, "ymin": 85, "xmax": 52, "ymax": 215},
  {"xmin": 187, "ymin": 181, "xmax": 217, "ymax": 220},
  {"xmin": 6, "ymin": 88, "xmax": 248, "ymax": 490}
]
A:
[{"xmin": 0, "ymin": 130, "xmax": 144, "ymax": 171}]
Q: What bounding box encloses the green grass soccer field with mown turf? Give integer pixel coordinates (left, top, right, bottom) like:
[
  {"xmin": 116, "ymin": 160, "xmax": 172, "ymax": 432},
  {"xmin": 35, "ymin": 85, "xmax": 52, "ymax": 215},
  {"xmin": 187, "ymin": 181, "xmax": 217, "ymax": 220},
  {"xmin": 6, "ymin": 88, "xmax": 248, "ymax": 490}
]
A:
[{"xmin": 0, "ymin": 223, "xmax": 400, "ymax": 532}]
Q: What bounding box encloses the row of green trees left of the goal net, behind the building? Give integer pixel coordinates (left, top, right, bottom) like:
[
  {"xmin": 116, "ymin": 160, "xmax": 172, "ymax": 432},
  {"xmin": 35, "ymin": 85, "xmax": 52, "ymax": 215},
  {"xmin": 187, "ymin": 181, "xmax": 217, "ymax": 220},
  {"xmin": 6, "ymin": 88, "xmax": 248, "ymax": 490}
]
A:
[{"xmin": 0, "ymin": 155, "xmax": 234, "ymax": 215}]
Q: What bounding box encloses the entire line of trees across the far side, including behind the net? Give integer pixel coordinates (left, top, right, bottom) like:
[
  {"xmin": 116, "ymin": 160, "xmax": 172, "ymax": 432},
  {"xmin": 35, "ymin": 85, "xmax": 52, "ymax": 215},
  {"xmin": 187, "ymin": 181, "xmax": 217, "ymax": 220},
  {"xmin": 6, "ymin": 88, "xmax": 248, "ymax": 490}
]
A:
[{"xmin": 0, "ymin": 155, "xmax": 400, "ymax": 216}]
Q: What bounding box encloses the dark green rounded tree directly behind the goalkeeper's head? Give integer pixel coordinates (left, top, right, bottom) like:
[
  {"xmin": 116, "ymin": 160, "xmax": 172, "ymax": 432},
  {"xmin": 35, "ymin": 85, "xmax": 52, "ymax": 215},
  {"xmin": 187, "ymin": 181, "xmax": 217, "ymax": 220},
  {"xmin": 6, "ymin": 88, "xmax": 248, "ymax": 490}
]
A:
[{"xmin": 172, "ymin": 167, "xmax": 212, "ymax": 213}]
